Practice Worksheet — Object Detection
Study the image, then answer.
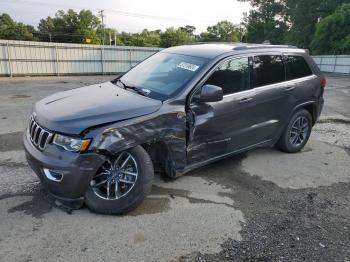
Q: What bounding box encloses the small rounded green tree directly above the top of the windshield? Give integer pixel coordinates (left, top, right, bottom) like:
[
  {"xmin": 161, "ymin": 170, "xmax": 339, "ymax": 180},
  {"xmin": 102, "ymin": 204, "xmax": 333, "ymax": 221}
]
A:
[{"xmin": 160, "ymin": 27, "xmax": 193, "ymax": 47}]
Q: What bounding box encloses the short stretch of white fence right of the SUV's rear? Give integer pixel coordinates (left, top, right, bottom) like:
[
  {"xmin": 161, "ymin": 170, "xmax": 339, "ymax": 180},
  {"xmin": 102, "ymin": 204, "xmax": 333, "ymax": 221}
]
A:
[{"xmin": 313, "ymin": 55, "xmax": 350, "ymax": 74}]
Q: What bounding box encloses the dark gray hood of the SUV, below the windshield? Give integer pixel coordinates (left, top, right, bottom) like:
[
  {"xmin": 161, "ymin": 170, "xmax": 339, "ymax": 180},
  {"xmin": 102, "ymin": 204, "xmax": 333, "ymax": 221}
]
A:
[{"xmin": 34, "ymin": 82, "xmax": 162, "ymax": 134}]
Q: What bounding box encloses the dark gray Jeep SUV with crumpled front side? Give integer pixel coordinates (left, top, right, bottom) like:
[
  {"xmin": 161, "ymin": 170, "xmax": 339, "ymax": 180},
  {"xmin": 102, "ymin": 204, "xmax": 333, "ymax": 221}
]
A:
[{"xmin": 24, "ymin": 44, "xmax": 326, "ymax": 214}]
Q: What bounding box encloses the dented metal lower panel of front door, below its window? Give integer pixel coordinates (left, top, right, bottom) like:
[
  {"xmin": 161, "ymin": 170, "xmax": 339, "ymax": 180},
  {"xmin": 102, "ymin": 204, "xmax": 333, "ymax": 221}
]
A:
[{"xmin": 187, "ymin": 90, "xmax": 255, "ymax": 164}]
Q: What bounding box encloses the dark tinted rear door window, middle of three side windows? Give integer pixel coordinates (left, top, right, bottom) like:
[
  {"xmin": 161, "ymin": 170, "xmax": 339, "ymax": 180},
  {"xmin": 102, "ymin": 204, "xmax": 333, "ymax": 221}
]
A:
[{"xmin": 253, "ymin": 55, "xmax": 286, "ymax": 87}]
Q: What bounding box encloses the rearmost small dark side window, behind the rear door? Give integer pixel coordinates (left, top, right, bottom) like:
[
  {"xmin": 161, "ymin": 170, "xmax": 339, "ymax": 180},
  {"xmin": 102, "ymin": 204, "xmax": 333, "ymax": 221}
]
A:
[{"xmin": 286, "ymin": 56, "xmax": 312, "ymax": 80}]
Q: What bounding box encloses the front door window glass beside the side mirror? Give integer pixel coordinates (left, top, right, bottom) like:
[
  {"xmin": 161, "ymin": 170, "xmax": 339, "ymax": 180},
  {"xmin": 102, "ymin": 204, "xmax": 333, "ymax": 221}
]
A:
[{"xmin": 206, "ymin": 57, "xmax": 250, "ymax": 95}]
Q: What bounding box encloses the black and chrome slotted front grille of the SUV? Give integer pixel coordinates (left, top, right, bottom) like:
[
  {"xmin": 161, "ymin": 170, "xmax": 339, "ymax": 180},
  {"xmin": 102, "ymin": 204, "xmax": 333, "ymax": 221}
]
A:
[{"xmin": 28, "ymin": 116, "xmax": 53, "ymax": 150}]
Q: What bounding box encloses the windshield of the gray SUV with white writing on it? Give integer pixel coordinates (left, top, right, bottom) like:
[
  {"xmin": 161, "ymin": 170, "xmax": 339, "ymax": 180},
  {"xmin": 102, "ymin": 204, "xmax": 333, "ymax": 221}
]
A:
[{"xmin": 120, "ymin": 52, "xmax": 208, "ymax": 100}]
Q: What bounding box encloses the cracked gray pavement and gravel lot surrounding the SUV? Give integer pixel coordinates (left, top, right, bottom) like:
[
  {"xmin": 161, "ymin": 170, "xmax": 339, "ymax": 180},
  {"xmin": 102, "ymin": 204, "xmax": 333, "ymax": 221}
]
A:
[{"xmin": 0, "ymin": 75, "xmax": 350, "ymax": 262}]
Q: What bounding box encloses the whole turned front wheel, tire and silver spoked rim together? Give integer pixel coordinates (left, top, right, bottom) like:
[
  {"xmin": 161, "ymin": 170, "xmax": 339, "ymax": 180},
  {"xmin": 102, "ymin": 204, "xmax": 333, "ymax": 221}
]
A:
[{"xmin": 85, "ymin": 146, "xmax": 154, "ymax": 214}]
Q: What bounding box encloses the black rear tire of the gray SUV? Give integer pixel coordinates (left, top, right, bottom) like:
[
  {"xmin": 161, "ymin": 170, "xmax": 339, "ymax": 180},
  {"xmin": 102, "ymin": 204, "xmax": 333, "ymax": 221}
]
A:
[{"xmin": 276, "ymin": 109, "xmax": 312, "ymax": 153}]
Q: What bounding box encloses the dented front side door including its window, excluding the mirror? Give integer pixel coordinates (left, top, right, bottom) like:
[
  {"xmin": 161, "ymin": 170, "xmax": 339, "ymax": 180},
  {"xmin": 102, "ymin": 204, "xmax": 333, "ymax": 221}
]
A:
[{"xmin": 187, "ymin": 57, "xmax": 258, "ymax": 164}]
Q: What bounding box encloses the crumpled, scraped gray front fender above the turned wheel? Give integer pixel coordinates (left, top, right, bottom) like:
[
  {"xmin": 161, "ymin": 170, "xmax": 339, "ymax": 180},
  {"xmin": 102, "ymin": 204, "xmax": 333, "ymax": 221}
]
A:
[{"xmin": 93, "ymin": 111, "xmax": 186, "ymax": 173}]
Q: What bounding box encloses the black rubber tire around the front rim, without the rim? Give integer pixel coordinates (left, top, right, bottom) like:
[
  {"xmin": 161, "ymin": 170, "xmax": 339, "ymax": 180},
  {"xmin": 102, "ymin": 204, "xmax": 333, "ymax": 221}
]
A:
[{"xmin": 85, "ymin": 146, "xmax": 154, "ymax": 215}]
